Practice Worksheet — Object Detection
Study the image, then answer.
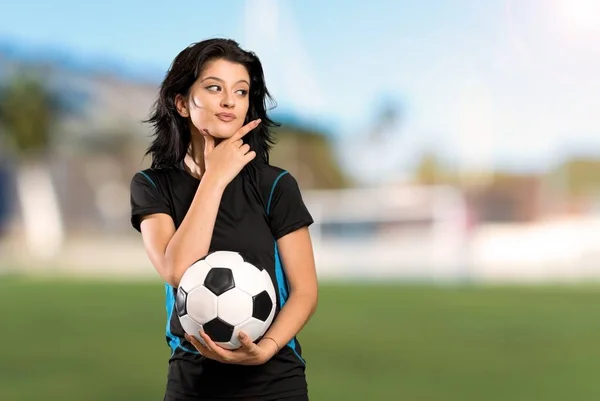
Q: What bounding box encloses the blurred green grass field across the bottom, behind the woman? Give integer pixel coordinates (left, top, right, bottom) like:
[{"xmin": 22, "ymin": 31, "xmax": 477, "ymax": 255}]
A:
[{"xmin": 0, "ymin": 277, "xmax": 600, "ymax": 401}]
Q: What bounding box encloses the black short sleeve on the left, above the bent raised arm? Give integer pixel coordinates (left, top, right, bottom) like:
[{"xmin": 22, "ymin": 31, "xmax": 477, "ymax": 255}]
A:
[{"xmin": 130, "ymin": 172, "xmax": 170, "ymax": 231}]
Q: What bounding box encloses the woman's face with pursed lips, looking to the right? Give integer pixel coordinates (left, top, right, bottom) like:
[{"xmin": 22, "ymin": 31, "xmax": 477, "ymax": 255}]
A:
[{"xmin": 175, "ymin": 59, "xmax": 250, "ymax": 139}]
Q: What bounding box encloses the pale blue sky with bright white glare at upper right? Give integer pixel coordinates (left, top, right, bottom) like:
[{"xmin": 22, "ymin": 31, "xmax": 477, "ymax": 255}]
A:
[{"xmin": 0, "ymin": 0, "xmax": 600, "ymax": 181}]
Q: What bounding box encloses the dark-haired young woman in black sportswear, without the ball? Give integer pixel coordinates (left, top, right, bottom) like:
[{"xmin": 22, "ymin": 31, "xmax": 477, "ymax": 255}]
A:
[{"xmin": 131, "ymin": 39, "xmax": 317, "ymax": 401}]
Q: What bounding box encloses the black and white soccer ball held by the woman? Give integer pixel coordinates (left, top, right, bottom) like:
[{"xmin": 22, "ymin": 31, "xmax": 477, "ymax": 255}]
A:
[{"xmin": 175, "ymin": 251, "xmax": 277, "ymax": 349}]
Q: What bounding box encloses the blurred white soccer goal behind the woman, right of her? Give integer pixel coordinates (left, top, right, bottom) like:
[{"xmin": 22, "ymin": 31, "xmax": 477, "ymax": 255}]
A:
[{"xmin": 304, "ymin": 186, "xmax": 468, "ymax": 281}]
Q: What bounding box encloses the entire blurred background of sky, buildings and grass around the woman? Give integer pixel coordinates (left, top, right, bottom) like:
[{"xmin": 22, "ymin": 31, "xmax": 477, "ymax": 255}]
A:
[{"xmin": 0, "ymin": 0, "xmax": 600, "ymax": 401}]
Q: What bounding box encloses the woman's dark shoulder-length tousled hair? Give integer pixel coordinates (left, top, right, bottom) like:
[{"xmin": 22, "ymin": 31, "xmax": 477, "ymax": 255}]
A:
[{"xmin": 145, "ymin": 38, "xmax": 279, "ymax": 168}]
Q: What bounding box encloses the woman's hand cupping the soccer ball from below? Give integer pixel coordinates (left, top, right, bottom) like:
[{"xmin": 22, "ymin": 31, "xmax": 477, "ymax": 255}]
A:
[{"xmin": 185, "ymin": 330, "xmax": 279, "ymax": 365}]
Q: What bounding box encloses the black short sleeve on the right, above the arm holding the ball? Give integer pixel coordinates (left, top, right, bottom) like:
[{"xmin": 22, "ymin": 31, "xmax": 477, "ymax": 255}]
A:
[{"xmin": 267, "ymin": 172, "xmax": 314, "ymax": 240}]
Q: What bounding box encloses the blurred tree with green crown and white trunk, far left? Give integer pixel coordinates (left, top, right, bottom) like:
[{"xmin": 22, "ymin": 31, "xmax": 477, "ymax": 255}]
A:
[{"xmin": 0, "ymin": 69, "xmax": 64, "ymax": 257}]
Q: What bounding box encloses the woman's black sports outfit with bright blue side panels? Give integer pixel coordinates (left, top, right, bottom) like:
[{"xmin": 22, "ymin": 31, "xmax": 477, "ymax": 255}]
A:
[{"xmin": 131, "ymin": 163, "xmax": 313, "ymax": 400}]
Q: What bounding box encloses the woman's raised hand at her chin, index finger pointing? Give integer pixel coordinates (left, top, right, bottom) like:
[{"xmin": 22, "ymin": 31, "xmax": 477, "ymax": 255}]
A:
[{"xmin": 201, "ymin": 119, "xmax": 260, "ymax": 187}]
